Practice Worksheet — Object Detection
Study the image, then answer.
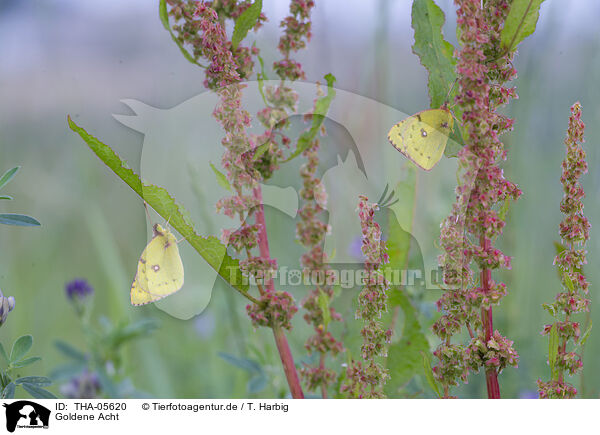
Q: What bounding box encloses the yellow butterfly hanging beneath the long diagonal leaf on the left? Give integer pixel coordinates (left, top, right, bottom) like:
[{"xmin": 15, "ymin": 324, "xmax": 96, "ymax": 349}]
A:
[{"xmin": 131, "ymin": 224, "xmax": 183, "ymax": 305}]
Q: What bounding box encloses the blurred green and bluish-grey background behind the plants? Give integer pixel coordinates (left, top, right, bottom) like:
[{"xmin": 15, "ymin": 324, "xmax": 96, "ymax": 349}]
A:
[{"xmin": 0, "ymin": 0, "xmax": 600, "ymax": 398}]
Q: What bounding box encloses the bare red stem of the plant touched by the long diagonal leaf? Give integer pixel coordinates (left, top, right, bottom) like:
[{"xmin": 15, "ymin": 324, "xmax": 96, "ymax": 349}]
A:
[{"xmin": 253, "ymin": 186, "xmax": 304, "ymax": 399}]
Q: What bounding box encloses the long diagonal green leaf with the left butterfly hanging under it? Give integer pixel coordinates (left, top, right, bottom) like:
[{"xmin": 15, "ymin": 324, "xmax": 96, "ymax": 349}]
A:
[{"xmin": 68, "ymin": 117, "xmax": 248, "ymax": 295}]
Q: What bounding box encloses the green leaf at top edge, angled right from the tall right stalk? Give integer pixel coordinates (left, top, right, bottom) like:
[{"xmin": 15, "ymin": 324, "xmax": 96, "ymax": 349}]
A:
[{"xmin": 500, "ymin": 0, "xmax": 544, "ymax": 52}]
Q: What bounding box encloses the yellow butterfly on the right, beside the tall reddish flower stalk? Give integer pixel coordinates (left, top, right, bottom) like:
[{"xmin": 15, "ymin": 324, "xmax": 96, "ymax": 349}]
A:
[{"xmin": 388, "ymin": 106, "xmax": 454, "ymax": 171}]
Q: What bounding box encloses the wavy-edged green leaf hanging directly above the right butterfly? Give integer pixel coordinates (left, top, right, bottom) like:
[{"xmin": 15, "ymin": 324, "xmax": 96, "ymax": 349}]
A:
[{"xmin": 412, "ymin": 0, "xmax": 456, "ymax": 108}]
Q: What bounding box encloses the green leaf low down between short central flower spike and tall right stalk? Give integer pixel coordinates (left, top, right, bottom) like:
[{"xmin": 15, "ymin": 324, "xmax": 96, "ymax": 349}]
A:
[{"xmin": 385, "ymin": 288, "xmax": 429, "ymax": 397}]
